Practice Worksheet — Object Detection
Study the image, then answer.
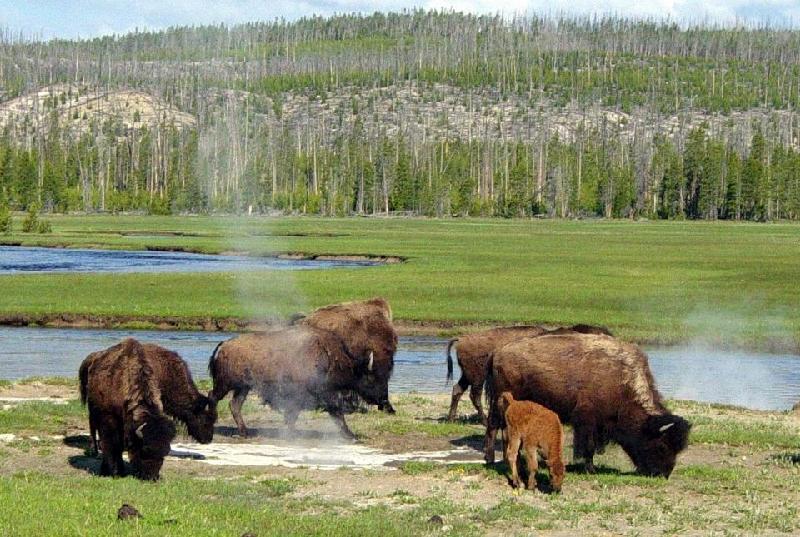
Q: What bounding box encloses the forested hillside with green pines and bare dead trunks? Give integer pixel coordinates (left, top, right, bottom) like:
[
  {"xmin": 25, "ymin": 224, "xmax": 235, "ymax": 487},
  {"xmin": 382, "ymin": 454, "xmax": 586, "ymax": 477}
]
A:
[{"xmin": 0, "ymin": 11, "xmax": 800, "ymax": 220}]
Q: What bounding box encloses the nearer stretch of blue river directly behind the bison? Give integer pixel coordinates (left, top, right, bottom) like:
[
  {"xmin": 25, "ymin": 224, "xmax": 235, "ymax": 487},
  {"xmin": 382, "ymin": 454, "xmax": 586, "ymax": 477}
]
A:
[{"xmin": 0, "ymin": 327, "xmax": 800, "ymax": 410}]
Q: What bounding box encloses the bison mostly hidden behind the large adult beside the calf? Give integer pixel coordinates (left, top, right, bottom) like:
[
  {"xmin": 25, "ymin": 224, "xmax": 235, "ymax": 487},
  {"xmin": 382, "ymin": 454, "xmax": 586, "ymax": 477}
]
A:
[{"xmin": 447, "ymin": 324, "xmax": 611, "ymax": 425}]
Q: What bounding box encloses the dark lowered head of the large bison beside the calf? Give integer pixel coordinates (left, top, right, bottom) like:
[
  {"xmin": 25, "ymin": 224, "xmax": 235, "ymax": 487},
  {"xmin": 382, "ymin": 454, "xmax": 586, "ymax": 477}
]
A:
[{"xmin": 629, "ymin": 414, "xmax": 691, "ymax": 478}]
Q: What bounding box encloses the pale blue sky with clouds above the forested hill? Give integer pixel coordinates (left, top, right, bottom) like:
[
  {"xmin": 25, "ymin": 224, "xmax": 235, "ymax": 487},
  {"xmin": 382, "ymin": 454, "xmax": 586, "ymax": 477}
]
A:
[{"xmin": 0, "ymin": 0, "xmax": 800, "ymax": 39}]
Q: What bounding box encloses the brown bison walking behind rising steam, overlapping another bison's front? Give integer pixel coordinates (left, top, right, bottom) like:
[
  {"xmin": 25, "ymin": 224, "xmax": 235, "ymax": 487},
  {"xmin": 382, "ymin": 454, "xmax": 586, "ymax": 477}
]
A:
[{"xmin": 208, "ymin": 326, "xmax": 386, "ymax": 438}]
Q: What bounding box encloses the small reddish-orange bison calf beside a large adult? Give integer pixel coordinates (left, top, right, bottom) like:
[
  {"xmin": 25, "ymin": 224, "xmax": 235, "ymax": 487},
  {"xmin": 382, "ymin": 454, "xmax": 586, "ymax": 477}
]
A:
[{"xmin": 500, "ymin": 392, "xmax": 564, "ymax": 491}]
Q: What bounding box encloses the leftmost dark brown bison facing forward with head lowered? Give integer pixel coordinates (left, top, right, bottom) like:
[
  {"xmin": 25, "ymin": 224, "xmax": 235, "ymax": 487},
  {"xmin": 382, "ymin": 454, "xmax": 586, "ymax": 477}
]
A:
[{"xmin": 80, "ymin": 339, "xmax": 175, "ymax": 480}]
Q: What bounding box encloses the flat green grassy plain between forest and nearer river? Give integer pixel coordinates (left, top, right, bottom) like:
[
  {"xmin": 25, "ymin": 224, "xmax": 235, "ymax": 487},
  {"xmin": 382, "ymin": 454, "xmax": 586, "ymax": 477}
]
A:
[{"xmin": 0, "ymin": 216, "xmax": 800, "ymax": 349}]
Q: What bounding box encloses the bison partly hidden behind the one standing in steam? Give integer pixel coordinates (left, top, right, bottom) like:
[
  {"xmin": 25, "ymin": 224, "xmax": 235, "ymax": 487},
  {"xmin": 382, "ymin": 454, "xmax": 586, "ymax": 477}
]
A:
[{"xmin": 294, "ymin": 298, "xmax": 397, "ymax": 414}]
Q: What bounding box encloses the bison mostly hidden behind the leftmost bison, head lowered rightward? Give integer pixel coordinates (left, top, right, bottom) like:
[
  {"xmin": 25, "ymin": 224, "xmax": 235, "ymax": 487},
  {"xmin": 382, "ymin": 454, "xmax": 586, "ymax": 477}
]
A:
[{"xmin": 78, "ymin": 343, "xmax": 217, "ymax": 453}]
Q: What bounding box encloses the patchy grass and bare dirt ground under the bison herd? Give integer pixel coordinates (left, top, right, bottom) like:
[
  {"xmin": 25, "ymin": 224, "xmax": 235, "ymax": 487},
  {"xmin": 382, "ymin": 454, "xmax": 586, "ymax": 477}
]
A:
[{"xmin": 0, "ymin": 382, "xmax": 800, "ymax": 537}]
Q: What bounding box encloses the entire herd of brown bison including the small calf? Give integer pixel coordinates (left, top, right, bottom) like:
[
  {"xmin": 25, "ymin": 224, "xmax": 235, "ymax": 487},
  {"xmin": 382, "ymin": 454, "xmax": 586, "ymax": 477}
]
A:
[{"xmin": 79, "ymin": 298, "xmax": 690, "ymax": 490}]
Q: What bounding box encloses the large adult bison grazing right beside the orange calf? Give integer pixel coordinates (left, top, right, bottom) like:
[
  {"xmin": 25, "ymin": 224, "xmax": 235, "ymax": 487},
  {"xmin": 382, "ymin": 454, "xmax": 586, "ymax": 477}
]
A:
[{"xmin": 485, "ymin": 333, "xmax": 690, "ymax": 477}]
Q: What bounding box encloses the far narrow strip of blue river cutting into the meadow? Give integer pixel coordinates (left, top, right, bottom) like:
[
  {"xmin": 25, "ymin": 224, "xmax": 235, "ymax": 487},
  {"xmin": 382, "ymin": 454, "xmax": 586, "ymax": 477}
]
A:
[{"xmin": 0, "ymin": 246, "xmax": 376, "ymax": 274}]
